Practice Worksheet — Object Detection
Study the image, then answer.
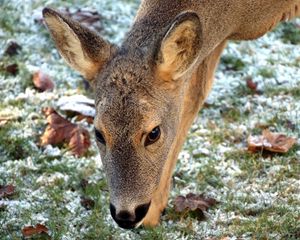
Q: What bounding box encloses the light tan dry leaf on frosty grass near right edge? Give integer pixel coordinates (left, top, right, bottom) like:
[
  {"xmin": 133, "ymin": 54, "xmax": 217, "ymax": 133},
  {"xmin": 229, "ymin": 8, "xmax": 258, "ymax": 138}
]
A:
[{"xmin": 248, "ymin": 129, "xmax": 297, "ymax": 153}]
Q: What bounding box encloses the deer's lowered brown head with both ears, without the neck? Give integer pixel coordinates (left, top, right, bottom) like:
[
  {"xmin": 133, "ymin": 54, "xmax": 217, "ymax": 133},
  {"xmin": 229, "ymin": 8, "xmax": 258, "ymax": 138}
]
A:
[{"xmin": 43, "ymin": 8, "xmax": 202, "ymax": 228}]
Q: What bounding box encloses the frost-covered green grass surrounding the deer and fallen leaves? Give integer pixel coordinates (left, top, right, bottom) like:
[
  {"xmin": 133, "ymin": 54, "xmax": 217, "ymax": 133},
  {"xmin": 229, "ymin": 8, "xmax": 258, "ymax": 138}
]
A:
[{"xmin": 0, "ymin": 0, "xmax": 300, "ymax": 240}]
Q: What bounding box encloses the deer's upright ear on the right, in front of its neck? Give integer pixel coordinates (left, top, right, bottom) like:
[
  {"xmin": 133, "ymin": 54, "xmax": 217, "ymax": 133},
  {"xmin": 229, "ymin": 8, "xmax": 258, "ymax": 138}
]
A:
[{"xmin": 157, "ymin": 12, "xmax": 202, "ymax": 80}]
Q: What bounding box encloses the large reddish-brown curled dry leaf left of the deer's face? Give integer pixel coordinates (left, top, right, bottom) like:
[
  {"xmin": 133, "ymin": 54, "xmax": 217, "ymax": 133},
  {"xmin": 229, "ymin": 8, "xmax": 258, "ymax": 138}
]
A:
[{"xmin": 41, "ymin": 108, "xmax": 91, "ymax": 156}]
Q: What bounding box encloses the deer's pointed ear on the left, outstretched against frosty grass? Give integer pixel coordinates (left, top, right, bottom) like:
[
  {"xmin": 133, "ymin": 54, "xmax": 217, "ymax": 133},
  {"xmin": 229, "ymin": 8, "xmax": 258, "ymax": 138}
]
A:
[{"xmin": 43, "ymin": 8, "xmax": 116, "ymax": 85}]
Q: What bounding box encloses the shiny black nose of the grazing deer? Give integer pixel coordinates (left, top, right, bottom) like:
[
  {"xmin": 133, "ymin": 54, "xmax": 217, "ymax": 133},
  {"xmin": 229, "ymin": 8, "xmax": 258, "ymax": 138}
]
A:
[{"xmin": 110, "ymin": 202, "xmax": 151, "ymax": 229}]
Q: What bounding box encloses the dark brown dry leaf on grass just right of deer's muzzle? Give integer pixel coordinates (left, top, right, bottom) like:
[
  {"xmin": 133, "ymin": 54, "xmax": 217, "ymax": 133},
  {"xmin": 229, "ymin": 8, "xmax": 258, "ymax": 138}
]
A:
[{"xmin": 174, "ymin": 193, "xmax": 217, "ymax": 212}]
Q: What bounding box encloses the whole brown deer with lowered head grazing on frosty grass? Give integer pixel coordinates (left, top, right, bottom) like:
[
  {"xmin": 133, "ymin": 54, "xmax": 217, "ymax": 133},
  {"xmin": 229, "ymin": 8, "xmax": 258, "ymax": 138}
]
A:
[{"xmin": 43, "ymin": 0, "xmax": 300, "ymax": 229}]
